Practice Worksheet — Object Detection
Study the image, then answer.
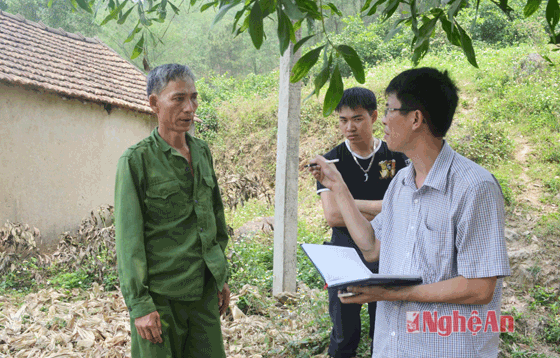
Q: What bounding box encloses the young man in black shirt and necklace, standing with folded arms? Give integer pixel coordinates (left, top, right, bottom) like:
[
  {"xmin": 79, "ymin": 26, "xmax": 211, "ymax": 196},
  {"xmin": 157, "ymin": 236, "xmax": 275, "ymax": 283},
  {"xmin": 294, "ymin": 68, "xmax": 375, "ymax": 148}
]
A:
[{"xmin": 317, "ymin": 87, "xmax": 407, "ymax": 358}]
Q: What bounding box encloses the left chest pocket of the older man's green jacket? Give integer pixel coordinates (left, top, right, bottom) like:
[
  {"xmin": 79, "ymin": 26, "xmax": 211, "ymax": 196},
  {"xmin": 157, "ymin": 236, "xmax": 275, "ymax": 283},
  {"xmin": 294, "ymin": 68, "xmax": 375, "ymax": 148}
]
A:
[{"xmin": 145, "ymin": 180, "xmax": 192, "ymax": 223}]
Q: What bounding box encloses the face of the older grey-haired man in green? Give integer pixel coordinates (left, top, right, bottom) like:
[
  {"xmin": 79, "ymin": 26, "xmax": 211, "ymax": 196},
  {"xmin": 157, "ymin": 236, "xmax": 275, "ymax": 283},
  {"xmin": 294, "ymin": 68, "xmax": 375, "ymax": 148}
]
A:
[{"xmin": 150, "ymin": 79, "xmax": 198, "ymax": 133}]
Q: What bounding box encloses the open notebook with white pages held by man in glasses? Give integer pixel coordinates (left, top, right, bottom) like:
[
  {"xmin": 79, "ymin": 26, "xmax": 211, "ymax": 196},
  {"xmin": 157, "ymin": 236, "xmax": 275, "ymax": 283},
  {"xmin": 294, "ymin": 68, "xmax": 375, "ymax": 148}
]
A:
[{"xmin": 301, "ymin": 244, "xmax": 422, "ymax": 289}]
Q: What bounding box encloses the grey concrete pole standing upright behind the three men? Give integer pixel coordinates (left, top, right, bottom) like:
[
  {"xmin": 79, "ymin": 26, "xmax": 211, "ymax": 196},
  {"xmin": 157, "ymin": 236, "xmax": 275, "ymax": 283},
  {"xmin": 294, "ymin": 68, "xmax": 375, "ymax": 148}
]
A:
[{"xmin": 272, "ymin": 30, "xmax": 301, "ymax": 295}]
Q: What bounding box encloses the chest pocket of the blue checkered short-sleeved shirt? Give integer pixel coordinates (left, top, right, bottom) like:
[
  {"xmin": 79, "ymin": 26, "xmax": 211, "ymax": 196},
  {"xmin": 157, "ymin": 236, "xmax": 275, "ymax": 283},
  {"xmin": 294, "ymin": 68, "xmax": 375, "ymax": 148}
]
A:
[{"xmin": 415, "ymin": 227, "xmax": 455, "ymax": 283}]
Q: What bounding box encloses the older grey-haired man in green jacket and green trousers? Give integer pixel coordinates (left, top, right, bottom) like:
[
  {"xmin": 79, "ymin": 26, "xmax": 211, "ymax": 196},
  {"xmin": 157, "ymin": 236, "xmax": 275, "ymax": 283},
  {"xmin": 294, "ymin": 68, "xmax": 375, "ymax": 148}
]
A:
[{"xmin": 115, "ymin": 64, "xmax": 230, "ymax": 358}]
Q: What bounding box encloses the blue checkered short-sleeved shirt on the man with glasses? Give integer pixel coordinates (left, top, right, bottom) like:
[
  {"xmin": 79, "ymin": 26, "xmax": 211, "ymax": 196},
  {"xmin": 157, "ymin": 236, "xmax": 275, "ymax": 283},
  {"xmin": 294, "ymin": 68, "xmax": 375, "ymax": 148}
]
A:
[{"xmin": 371, "ymin": 142, "xmax": 510, "ymax": 358}]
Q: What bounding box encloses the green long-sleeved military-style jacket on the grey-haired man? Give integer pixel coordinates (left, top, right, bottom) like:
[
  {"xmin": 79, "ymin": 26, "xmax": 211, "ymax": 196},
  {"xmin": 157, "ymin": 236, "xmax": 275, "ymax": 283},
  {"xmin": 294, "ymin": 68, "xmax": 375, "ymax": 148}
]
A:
[{"xmin": 115, "ymin": 128, "xmax": 228, "ymax": 318}]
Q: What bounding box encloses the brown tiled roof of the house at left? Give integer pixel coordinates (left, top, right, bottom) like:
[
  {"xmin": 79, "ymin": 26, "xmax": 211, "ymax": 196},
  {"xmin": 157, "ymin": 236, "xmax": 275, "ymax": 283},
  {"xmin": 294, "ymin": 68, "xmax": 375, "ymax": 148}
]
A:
[{"xmin": 0, "ymin": 11, "xmax": 152, "ymax": 113}]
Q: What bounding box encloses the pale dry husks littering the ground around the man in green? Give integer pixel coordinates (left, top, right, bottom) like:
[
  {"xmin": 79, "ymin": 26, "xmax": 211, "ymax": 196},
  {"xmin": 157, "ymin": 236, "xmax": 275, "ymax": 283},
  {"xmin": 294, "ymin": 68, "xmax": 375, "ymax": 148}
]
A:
[{"xmin": 0, "ymin": 284, "xmax": 325, "ymax": 358}]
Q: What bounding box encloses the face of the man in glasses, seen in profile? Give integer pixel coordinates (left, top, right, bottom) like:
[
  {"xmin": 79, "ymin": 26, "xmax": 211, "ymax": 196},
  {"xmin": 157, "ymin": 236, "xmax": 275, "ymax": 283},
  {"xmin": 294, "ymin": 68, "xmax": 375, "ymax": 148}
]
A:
[{"xmin": 381, "ymin": 94, "xmax": 414, "ymax": 152}]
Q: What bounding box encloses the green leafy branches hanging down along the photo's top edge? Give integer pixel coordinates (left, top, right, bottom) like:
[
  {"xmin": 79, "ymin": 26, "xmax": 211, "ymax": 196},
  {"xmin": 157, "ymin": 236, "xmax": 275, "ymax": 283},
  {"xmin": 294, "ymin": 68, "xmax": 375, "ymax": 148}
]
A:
[{"xmin": 49, "ymin": 0, "xmax": 560, "ymax": 115}]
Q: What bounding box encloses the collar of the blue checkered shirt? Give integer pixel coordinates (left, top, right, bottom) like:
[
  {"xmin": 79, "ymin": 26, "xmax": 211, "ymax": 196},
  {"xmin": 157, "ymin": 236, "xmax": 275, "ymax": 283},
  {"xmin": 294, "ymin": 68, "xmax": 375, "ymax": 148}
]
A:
[{"xmin": 402, "ymin": 140, "xmax": 455, "ymax": 191}]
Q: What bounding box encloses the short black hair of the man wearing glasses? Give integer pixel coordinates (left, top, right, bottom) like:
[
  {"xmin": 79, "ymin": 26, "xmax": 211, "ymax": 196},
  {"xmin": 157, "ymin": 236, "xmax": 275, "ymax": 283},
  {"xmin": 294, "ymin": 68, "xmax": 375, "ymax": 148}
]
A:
[{"xmin": 385, "ymin": 67, "xmax": 459, "ymax": 138}]
